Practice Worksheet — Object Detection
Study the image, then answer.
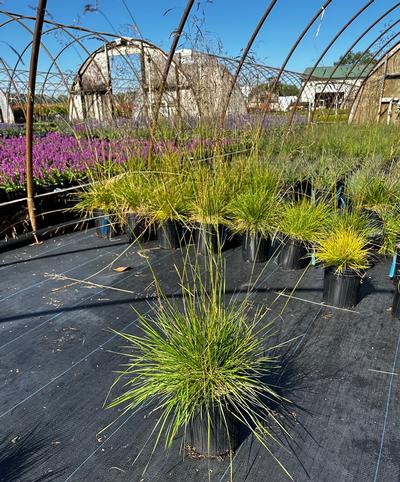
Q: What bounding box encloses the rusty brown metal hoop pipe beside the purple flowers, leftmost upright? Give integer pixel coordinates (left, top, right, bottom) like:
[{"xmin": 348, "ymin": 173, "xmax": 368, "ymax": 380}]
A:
[{"xmin": 25, "ymin": 0, "xmax": 47, "ymax": 233}]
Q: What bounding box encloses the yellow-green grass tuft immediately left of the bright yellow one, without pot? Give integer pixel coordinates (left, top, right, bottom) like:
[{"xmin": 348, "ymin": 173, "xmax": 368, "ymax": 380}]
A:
[{"xmin": 279, "ymin": 199, "xmax": 331, "ymax": 243}]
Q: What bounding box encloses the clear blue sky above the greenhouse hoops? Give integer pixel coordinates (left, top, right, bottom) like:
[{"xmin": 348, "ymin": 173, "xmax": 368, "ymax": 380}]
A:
[{"xmin": 0, "ymin": 0, "xmax": 400, "ymax": 71}]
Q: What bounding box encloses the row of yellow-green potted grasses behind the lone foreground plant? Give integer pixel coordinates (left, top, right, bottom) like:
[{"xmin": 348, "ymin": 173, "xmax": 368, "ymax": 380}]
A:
[{"xmin": 76, "ymin": 158, "xmax": 400, "ymax": 310}]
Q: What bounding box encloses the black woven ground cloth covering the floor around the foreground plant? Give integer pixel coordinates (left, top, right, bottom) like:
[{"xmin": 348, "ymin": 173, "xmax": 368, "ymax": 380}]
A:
[{"xmin": 0, "ymin": 230, "xmax": 400, "ymax": 482}]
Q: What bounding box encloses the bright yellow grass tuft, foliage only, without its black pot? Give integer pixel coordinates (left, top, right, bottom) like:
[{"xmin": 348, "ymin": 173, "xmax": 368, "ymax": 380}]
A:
[{"xmin": 315, "ymin": 227, "xmax": 370, "ymax": 273}]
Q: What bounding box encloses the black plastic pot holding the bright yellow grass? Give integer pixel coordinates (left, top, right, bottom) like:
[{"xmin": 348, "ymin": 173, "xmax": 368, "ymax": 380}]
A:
[{"xmin": 322, "ymin": 266, "xmax": 361, "ymax": 308}]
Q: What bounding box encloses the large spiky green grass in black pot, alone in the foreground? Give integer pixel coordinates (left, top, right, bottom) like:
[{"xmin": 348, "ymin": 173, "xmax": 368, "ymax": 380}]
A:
[{"xmin": 108, "ymin": 257, "xmax": 290, "ymax": 480}]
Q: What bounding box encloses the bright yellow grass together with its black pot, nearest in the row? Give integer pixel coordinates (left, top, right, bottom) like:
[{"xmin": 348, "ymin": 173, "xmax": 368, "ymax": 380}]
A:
[{"xmin": 315, "ymin": 226, "xmax": 370, "ymax": 308}]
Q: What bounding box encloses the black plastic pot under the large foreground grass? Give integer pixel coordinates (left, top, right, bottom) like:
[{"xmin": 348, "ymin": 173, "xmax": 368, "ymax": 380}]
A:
[{"xmin": 187, "ymin": 409, "xmax": 246, "ymax": 457}]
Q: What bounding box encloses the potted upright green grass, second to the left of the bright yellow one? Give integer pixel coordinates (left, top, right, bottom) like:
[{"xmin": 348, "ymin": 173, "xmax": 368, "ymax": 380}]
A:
[{"xmin": 229, "ymin": 165, "xmax": 280, "ymax": 263}]
